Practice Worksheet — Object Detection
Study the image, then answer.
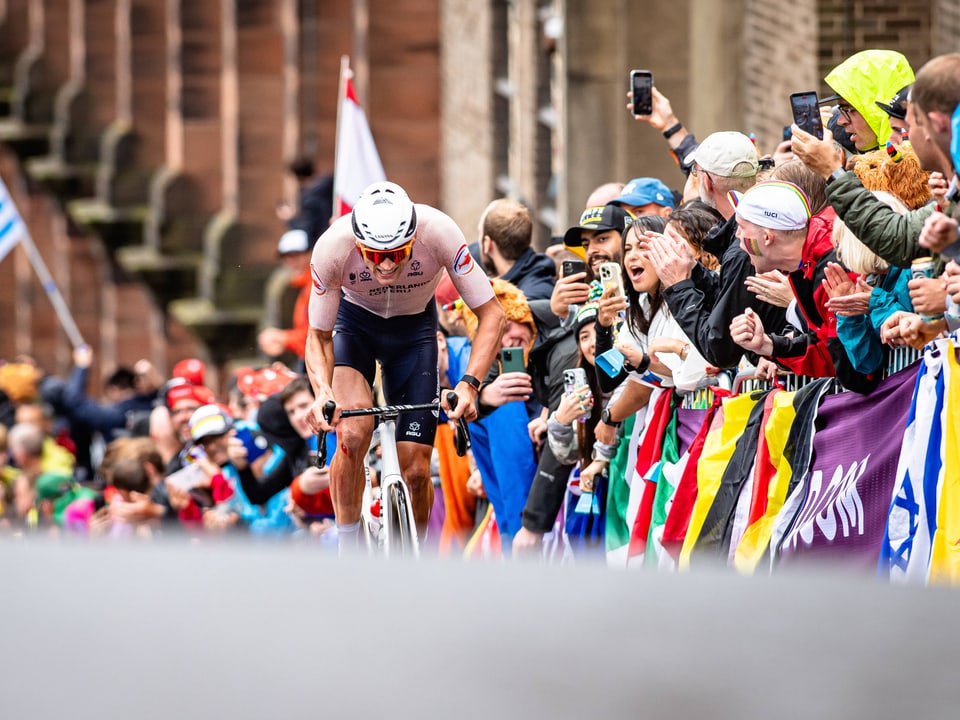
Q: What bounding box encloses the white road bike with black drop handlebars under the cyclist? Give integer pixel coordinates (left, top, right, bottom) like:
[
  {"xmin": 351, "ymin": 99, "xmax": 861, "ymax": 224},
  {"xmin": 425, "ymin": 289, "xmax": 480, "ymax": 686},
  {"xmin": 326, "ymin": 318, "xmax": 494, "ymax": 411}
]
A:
[{"xmin": 317, "ymin": 392, "xmax": 470, "ymax": 557}]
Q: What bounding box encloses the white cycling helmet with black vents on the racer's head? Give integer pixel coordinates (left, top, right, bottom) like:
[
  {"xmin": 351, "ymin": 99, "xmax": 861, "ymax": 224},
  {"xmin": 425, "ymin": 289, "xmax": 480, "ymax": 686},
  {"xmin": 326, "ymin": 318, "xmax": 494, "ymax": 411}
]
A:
[{"xmin": 351, "ymin": 182, "xmax": 417, "ymax": 250}]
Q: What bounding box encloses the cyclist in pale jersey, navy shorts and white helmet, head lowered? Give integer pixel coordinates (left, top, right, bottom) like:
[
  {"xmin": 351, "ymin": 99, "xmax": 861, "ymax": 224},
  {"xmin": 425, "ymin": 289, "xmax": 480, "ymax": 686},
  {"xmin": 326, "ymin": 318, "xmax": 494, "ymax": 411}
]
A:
[{"xmin": 305, "ymin": 182, "xmax": 506, "ymax": 549}]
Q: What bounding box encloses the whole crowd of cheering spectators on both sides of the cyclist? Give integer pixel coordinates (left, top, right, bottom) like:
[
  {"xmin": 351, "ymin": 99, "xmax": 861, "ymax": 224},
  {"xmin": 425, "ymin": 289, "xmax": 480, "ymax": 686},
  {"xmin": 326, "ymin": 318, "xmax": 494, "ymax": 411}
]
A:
[{"xmin": 0, "ymin": 50, "xmax": 960, "ymax": 557}]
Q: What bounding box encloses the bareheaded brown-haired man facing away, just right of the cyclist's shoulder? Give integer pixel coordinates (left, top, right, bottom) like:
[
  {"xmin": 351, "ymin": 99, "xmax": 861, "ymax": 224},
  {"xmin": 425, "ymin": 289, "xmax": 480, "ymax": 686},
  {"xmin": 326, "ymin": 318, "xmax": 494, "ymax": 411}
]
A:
[{"xmin": 480, "ymin": 199, "xmax": 557, "ymax": 300}]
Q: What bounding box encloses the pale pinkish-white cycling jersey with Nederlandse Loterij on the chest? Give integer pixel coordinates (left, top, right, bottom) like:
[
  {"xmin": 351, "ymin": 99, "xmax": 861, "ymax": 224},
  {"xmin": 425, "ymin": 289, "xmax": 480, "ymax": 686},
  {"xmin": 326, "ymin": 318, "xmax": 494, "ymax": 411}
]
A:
[{"xmin": 310, "ymin": 205, "xmax": 494, "ymax": 331}]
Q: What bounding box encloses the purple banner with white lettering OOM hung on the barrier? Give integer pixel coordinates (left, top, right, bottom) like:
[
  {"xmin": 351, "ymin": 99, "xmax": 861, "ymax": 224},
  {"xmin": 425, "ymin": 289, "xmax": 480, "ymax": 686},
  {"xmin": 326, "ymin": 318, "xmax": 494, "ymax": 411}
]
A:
[{"xmin": 780, "ymin": 368, "xmax": 917, "ymax": 572}]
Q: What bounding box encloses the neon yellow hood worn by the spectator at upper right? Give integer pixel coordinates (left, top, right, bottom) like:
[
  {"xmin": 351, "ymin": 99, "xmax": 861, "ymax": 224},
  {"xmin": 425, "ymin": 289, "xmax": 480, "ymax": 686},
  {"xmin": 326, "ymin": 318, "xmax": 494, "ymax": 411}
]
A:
[{"xmin": 824, "ymin": 50, "xmax": 913, "ymax": 150}]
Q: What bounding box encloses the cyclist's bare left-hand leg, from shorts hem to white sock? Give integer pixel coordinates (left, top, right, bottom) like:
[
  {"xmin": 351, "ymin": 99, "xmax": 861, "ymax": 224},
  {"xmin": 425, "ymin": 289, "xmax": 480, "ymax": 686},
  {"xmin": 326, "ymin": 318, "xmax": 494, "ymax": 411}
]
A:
[{"xmin": 330, "ymin": 365, "xmax": 373, "ymax": 525}]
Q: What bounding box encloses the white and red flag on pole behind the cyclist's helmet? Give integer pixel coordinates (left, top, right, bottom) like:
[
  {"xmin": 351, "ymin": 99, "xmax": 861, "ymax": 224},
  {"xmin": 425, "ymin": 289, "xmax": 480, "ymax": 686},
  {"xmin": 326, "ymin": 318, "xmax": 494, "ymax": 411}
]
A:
[{"xmin": 333, "ymin": 63, "xmax": 387, "ymax": 217}]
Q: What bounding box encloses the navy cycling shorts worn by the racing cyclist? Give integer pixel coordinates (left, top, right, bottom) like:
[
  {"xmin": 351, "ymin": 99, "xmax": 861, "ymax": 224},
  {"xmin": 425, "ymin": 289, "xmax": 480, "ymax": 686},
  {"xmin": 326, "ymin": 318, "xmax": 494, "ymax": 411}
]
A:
[{"xmin": 333, "ymin": 300, "xmax": 440, "ymax": 445}]
